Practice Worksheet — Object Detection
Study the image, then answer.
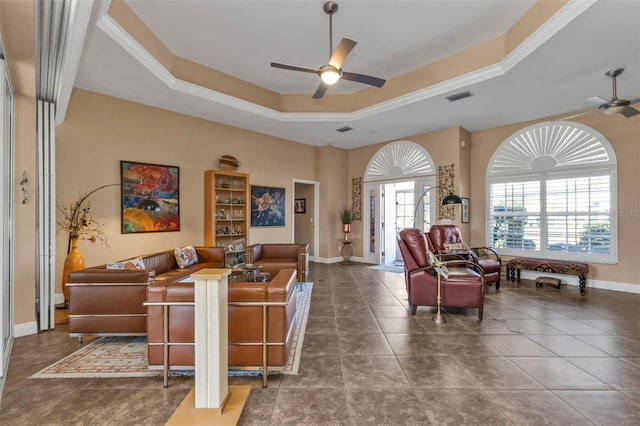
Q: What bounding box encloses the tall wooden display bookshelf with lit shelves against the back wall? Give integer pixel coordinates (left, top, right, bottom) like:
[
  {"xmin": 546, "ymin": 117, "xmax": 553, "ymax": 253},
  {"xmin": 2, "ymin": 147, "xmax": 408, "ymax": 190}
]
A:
[{"xmin": 204, "ymin": 170, "xmax": 251, "ymax": 266}]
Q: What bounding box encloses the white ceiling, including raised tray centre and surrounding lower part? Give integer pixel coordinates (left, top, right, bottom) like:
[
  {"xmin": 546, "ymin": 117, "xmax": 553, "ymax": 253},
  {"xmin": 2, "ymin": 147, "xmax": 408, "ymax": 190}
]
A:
[{"xmin": 75, "ymin": 0, "xmax": 640, "ymax": 149}]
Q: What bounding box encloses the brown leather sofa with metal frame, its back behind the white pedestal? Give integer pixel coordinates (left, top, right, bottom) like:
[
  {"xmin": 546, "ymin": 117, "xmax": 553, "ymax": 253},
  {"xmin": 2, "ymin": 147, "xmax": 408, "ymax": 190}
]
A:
[{"xmin": 147, "ymin": 269, "xmax": 297, "ymax": 379}]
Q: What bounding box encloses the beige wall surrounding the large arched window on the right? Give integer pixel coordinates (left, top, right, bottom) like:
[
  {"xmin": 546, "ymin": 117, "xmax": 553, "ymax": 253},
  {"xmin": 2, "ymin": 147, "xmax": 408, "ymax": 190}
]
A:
[{"xmin": 470, "ymin": 111, "xmax": 640, "ymax": 284}]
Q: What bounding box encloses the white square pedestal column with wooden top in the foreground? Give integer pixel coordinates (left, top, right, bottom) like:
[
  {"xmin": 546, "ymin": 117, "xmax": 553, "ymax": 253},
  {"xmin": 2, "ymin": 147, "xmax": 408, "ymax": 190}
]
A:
[{"xmin": 191, "ymin": 269, "xmax": 231, "ymax": 410}]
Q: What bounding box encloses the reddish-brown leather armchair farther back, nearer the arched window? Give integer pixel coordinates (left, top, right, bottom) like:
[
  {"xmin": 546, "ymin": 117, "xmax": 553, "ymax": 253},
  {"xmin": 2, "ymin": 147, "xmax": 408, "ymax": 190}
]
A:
[{"xmin": 429, "ymin": 225, "xmax": 502, "ymax": 290}]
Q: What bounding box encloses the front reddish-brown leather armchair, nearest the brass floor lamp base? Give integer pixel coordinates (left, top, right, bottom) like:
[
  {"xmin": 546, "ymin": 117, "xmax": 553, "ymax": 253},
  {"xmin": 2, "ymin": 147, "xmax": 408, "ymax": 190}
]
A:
[{"xmin": 398, "ymin": 228, "xmax": 485, "ymax": 321}]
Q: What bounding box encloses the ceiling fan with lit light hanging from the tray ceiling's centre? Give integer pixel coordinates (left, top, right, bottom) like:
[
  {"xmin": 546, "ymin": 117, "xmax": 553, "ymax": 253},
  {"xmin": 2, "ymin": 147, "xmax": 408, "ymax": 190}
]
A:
[{"xmin": 271, "ymin": 1, "xmax": 386, "ymax": 99}]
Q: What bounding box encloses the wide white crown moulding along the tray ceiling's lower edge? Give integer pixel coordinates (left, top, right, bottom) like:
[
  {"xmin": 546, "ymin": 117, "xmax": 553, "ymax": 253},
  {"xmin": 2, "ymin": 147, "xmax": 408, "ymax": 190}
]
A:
[{"xmin": 89, "ymin": 0, "xmax": 596, "ymax": 129}]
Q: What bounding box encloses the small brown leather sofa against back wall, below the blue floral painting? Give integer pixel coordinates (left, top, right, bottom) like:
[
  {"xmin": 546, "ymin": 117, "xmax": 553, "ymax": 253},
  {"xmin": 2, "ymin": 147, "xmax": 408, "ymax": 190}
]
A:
[{"xmin": 245, "ymin": 243, "xmax": 309, "ymax": 282}]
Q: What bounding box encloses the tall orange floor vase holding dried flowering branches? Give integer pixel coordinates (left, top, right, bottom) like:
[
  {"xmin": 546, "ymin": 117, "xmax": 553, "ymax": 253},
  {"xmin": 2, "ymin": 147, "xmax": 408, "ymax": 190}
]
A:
[{"xmin": 56, "ymin": 183, "xmax": 120, "ymax": 308}]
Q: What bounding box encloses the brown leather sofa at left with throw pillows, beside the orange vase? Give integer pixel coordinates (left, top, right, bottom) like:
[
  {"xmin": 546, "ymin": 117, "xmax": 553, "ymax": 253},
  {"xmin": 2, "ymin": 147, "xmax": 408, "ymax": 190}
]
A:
[{"xmin": 67, "ymin": 247, "xmax": 225, "ymax": 339}]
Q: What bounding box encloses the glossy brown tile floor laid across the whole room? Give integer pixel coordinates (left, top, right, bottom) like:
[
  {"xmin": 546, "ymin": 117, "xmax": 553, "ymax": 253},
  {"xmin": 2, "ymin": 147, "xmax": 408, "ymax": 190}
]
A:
[{"xmin": 0, "ymin": 264, "xmax": 640, "ymax": 425}]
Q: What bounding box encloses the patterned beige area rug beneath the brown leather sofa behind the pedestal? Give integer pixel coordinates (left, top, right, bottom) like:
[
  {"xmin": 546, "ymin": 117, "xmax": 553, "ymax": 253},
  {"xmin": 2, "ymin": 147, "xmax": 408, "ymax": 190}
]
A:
[{"xmin": 29, "ymin": 282, "xmax": 313, "ymax": 379}]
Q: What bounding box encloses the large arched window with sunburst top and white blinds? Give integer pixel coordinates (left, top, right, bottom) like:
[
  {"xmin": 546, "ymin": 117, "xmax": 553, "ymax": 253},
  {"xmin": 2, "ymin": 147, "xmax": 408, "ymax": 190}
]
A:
[{"xmin": 486, "ymin": 121, "xmax": 618, "ymax": 263}]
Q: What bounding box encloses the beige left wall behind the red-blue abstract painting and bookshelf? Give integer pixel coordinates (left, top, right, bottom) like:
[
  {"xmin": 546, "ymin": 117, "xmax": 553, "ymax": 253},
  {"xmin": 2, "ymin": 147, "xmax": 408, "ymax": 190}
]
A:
[{"xmin": 56, "ymin": 89, "xmax": 318, "ymax": 292}]
